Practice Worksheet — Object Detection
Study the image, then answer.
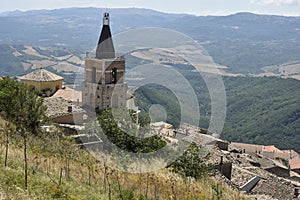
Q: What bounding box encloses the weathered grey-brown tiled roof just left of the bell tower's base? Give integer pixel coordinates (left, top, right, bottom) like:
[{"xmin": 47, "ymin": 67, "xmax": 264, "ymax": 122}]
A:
[{"xmin": 44, "ymin": 97, "xmax": 85, "ymax": 118}]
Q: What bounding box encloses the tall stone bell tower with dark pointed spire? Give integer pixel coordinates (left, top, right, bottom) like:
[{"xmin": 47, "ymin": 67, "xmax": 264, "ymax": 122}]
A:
[{"xmin": 82, "ymin": 13, "xmax": 127, "ymax": 112}]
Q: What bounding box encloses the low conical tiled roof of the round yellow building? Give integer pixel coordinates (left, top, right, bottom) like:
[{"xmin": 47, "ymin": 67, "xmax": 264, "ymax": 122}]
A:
[{"xmin": 20, "ymin": 69, "xmax": 63, "ymax": 82}]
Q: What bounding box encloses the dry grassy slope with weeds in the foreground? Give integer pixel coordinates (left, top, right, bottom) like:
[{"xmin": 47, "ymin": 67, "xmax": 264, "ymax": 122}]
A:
[{"xmin": 0, "ymin": 126, "xmax": 245, "ymax": 200}]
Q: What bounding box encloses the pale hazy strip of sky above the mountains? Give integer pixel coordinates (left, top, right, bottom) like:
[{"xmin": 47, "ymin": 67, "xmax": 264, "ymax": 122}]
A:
[{"xmin": 0, "ymin": 0, "xmax": 300, "ymax": 16}]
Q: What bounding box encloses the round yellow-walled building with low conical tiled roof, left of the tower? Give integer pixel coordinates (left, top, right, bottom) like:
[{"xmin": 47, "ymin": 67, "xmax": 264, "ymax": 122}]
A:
[{"xmin": 19, "ymin": 69, "xmax": 63, "ymax": 96}]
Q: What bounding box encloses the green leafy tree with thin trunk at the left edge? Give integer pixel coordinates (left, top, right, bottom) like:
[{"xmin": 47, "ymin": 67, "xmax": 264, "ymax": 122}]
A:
[{"xmin": 0, "ymin": 78, "xmax": 46, "ymax": 189}]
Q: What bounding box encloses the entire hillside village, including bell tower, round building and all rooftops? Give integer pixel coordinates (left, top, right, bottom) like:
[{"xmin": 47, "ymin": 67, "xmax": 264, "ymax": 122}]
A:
[{"xmin": 0, "ymin": 9, "xmax": 300, "ymax": 199}]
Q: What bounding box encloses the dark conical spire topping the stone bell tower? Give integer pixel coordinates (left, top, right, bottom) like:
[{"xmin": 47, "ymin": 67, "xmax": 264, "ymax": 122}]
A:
[{"xmin": 96, "ymin": 12, "xmax": 115, "ymax": 59}]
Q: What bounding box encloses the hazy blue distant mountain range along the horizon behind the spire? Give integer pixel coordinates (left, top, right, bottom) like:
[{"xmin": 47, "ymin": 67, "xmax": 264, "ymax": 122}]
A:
[{"xmin": 0, "ymin": 8, "xmax": 300, "ymax": 74}]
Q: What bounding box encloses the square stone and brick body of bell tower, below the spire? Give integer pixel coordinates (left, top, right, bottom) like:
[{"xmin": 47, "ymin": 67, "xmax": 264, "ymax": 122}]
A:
[{"xmin": 82, "ymin": 58, "xmax": 127, "ymax": 111}]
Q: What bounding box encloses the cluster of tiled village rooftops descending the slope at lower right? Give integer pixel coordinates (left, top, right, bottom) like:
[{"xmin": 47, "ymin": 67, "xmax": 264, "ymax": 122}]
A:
[{"xmin": 155, "ymin": 123, "xmax": 300, "ymax": 199}]
